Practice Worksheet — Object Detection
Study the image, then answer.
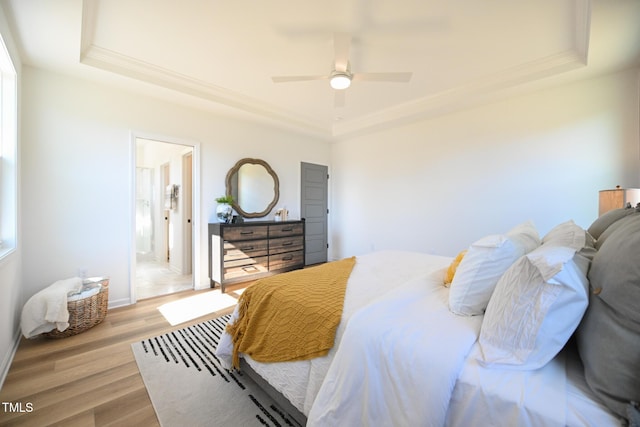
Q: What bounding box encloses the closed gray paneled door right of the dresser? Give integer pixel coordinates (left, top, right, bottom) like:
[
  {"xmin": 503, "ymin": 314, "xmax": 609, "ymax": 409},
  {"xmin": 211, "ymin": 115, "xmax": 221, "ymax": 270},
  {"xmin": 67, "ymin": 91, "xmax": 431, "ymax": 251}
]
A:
[{"xmin": 300, "ymin": 162, "xmax": 329, "ymax": 265}]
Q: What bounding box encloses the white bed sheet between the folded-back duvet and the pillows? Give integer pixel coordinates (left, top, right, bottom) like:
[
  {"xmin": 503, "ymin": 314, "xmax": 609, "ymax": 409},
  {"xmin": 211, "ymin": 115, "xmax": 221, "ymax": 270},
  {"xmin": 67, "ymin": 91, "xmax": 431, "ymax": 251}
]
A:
[{"xmin": 446, "ymin": 343, "xmax": 620, "ymax": 427}]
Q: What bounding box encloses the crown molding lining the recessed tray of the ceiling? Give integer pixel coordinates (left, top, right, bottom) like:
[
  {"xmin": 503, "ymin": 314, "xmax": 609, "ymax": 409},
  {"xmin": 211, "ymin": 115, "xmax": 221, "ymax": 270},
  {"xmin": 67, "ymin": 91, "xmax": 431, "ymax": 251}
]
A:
[{"xmin": 80, "ymin": 0, "xmax": 591, "ymax": 139}]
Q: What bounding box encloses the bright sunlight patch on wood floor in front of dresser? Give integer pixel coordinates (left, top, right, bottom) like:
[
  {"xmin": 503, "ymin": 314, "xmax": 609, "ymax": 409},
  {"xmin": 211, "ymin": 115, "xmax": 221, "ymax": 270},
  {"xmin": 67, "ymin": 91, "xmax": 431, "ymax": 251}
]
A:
[{"xmin": 158, "ymin": 290, "xmax": 238, "ymax": 326}]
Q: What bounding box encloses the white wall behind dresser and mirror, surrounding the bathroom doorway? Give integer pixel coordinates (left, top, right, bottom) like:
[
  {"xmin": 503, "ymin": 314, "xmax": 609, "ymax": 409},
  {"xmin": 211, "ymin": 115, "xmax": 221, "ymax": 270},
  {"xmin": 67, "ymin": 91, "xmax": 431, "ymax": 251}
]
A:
[{"xmin": 22, "ymin": 67, "xmax": 330, "ymax": 306}]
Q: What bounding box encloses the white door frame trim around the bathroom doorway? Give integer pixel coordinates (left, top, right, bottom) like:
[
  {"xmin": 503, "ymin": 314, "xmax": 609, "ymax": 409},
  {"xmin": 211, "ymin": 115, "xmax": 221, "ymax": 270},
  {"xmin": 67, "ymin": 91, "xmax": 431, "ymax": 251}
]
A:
[{"xmin": 129, "ymin": 131, "xmax": 201, "ymax": 304}]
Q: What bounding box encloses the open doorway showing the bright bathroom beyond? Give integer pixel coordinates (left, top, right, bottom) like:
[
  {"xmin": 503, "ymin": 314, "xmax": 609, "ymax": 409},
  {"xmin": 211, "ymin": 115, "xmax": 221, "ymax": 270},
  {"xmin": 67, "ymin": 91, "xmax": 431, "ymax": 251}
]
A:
[{"xmin": 134, "ymin": 138, "xmax": 194, "ymax": 299}]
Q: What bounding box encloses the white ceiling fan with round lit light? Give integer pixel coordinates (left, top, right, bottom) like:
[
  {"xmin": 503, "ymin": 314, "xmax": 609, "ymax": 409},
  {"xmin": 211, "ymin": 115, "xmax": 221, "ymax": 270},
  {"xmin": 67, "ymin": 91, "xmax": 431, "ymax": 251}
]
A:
[{"xmin": 271, "ymin": 33, "xmax": 413, "ymax": 106}]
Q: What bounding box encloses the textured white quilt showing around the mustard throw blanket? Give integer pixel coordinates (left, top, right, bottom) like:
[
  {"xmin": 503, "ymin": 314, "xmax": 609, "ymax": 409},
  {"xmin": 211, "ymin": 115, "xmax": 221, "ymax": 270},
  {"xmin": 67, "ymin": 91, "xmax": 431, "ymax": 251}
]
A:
[{"xmin": 216, "ymin": 251, "xmax": 451, "ymax": 414}]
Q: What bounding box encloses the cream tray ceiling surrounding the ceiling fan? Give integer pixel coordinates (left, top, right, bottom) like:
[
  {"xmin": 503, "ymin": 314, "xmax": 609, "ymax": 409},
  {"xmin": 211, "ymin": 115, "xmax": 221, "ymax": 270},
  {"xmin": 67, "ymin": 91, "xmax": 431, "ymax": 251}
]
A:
[{"xmin": 2, "ymin": 0, "xmax": 640, "ymax": 139}]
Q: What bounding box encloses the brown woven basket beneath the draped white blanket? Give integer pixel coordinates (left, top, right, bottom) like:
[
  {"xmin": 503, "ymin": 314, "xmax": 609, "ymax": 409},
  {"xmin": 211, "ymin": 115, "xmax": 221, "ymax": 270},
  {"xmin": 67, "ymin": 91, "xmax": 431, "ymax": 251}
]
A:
[{"xmin": 42, "ymin": 277, "xmax": 109, "ymax": 338}]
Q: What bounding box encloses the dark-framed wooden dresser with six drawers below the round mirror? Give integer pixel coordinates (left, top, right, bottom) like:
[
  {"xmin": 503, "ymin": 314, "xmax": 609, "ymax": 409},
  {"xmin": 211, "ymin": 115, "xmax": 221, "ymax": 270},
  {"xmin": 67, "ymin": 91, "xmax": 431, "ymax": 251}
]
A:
[{"xmin": 209, "ymin": 220, "xmax": 305, "ymax": 292}]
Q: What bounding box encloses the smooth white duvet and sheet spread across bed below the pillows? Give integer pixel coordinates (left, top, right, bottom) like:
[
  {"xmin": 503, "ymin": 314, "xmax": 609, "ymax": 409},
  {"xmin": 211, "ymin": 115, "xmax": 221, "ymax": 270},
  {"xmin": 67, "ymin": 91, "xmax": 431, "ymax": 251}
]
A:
[{"xmin": 307, "ymin": 270, "xmax": 620, "ymax": 427}]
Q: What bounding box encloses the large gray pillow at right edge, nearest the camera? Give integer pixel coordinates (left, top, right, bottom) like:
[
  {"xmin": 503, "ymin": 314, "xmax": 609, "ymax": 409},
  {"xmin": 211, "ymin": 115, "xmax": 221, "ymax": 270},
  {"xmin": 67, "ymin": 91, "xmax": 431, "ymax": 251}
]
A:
[{"xmin": 576, "ymin": 213, "xmax": 640, "ymax": 418}]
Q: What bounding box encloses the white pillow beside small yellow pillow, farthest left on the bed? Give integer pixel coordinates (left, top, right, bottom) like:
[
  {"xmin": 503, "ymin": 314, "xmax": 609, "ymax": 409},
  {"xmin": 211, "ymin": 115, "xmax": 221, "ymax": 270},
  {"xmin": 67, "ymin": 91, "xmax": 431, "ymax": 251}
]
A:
[{"xmin": 449, "ymin": 221, "xmax": 540, "ymax": 316}]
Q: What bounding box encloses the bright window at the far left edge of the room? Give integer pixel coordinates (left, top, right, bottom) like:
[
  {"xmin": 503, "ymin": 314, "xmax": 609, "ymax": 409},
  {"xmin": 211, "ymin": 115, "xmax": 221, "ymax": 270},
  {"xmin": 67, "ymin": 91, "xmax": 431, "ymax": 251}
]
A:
[{"xmin": 0, "ymin": 31, "xmax": 18, "ymax": 258}]
